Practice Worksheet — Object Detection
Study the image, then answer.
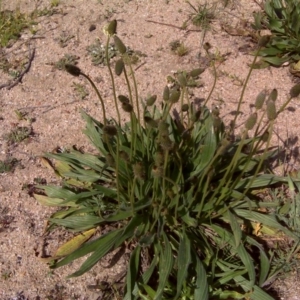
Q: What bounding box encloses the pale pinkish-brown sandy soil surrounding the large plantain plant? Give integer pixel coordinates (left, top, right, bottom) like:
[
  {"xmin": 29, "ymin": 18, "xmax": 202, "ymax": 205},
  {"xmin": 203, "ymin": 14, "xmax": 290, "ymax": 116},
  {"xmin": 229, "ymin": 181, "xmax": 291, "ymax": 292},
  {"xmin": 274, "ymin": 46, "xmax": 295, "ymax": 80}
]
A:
[{"xmin": 0, "ymin": 0, "xmax": 300, "ymax": 300}]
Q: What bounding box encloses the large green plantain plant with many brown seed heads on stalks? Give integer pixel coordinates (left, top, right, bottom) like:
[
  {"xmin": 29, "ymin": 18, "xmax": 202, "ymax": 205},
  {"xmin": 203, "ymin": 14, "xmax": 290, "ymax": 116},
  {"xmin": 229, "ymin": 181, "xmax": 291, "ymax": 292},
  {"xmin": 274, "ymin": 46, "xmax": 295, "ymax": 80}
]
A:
[{"xmin": 35, "ymin": 21, "xmax": 300, "ymax": 300}]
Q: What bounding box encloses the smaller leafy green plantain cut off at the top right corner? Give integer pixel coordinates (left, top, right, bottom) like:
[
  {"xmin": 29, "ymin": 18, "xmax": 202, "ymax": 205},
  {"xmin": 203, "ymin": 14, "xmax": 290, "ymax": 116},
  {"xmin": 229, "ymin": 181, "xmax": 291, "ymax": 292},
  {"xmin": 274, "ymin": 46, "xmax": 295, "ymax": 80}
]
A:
[{"xmin": 254, "ymin": 0, "xmax": 300, "ymax": 67}]
